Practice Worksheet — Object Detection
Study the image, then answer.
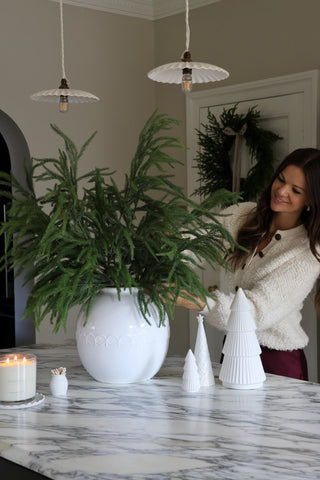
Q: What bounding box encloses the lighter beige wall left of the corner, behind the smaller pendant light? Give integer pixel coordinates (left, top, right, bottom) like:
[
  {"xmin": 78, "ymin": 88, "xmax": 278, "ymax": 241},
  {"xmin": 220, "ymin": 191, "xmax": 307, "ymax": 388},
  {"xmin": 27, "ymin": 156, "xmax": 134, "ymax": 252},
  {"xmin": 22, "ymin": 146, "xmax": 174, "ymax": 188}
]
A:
[{"xmin": 0, "ymin": 0, "xmax": 155, "ymax": 342}]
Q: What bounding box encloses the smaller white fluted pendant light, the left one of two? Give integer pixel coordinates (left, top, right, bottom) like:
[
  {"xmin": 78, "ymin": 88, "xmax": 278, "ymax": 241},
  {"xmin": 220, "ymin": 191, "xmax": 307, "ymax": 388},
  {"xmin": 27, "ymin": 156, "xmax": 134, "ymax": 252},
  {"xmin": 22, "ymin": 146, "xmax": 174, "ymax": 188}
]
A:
[{"xmin": 30, "ymin": 0, "xmax": 99, "ymax": 113}]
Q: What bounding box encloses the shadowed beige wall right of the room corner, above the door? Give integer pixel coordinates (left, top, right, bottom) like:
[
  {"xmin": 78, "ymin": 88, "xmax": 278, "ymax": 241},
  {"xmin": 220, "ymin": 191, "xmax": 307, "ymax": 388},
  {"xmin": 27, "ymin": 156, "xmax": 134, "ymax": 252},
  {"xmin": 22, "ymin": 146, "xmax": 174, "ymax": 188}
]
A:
[{"xmin": 155, "ymin": 0, "xmax": 320, "ymax": 353}]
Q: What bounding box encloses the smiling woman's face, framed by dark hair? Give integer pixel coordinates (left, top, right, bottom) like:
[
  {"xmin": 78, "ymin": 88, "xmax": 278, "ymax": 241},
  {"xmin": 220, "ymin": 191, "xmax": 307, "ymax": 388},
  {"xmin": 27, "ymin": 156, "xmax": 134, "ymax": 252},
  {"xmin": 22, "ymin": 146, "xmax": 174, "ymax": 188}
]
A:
[{"xmin": 270, "ymin": 165, "xmax": 309, "ymax": 219}]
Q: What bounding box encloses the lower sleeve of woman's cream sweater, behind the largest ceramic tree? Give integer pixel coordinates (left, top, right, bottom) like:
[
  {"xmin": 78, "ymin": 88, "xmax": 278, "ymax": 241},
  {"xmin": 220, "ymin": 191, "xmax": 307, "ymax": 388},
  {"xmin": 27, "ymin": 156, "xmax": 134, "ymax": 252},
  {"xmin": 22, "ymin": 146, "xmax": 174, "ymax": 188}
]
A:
[{"xmin": 204, "ymin": 251, "xmax": 320, "ymax": 331}]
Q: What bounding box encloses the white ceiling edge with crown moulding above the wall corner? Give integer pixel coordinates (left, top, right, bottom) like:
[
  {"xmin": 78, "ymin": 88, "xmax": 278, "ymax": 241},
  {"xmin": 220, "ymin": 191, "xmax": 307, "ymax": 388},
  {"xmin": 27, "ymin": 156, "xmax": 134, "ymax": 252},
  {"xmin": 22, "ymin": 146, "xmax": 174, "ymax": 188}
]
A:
[{"xmin": 51, "ymin": 0, "xmax": 221, "ymax": 20}]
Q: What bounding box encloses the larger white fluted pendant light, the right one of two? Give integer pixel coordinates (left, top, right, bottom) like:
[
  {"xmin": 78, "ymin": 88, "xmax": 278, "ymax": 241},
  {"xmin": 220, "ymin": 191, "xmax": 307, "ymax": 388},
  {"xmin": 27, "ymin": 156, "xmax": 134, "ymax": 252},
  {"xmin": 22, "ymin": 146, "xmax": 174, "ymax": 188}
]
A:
[{"xmin": 148, "ymin": 0, "xmax": 229, "ymax": 93}]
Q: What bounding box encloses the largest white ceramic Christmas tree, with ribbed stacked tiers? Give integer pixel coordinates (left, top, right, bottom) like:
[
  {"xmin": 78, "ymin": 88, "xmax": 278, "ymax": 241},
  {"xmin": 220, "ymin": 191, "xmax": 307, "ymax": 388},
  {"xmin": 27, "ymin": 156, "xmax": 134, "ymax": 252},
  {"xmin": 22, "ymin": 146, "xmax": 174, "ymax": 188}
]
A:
[{"xmin": 219, "ymin": 288, "xmax": 266, "ymax": 389}]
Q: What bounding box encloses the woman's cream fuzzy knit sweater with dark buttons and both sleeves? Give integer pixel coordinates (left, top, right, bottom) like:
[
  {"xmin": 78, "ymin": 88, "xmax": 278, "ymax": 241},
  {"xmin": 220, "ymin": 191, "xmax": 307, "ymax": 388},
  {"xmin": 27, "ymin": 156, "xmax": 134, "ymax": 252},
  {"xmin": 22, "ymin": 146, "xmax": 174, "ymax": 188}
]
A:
[{"xmin": 203, "ymin": 202, "xmax": 320, "ymax": 350}]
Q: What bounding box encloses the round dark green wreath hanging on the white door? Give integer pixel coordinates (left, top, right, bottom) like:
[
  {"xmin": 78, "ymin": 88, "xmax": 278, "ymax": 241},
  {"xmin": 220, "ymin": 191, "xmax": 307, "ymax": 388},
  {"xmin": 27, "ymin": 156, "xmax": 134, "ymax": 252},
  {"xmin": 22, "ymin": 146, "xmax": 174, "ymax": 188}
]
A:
[{"xmin": 195, "ymin": 104, "xmax": 281, "ymax": 201}]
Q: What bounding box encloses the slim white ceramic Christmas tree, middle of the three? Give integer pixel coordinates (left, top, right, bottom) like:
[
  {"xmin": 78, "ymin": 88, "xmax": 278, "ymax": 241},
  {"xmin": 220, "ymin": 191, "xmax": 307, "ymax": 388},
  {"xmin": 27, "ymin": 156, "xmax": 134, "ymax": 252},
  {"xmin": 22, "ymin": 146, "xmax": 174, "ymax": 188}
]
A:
[{"xmin": 194, "ymin": 314, "xmax": 214, "ymax": 387}]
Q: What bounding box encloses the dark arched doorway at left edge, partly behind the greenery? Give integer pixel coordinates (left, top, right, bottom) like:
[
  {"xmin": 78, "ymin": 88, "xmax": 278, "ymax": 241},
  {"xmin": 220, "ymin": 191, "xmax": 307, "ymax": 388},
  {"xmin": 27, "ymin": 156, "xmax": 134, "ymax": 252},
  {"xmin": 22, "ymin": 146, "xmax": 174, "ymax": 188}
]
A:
[{"xmin": 0, "ymin": 110, "xmax": 35, "ymax": 348}]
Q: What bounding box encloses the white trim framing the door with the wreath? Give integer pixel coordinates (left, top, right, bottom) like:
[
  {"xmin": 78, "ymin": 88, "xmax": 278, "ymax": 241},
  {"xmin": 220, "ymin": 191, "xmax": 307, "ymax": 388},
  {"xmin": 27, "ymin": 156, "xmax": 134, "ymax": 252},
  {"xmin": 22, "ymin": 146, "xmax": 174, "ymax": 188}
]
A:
[{"xmin": 186, "ymin": 70, "xmax": 320, "ymax": 195}]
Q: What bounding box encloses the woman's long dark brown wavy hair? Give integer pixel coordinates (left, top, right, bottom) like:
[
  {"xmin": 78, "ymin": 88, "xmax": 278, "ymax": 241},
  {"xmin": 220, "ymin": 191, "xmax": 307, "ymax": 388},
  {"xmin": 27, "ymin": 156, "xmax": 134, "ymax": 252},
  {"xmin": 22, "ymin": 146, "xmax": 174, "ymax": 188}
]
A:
[{"xmin": 230, "ymin": 148, "xmax": 320, "ymax": 313}]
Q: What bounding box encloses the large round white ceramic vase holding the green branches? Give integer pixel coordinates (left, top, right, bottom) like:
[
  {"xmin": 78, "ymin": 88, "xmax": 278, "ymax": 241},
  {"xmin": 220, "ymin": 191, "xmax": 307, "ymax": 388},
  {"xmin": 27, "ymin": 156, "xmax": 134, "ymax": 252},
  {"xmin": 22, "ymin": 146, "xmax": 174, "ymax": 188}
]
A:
[{"xmin": 76, "ymin": 288, "xmax": 170, "ymax": 383}]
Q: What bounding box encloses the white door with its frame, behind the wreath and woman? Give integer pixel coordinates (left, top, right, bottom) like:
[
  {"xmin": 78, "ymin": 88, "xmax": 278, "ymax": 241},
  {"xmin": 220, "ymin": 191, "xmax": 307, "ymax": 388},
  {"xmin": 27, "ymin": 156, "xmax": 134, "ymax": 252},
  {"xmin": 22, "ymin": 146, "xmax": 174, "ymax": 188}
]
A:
[{"xmin": 187, "ymin": 72, "xmax": 318, "ymax": 381}]
